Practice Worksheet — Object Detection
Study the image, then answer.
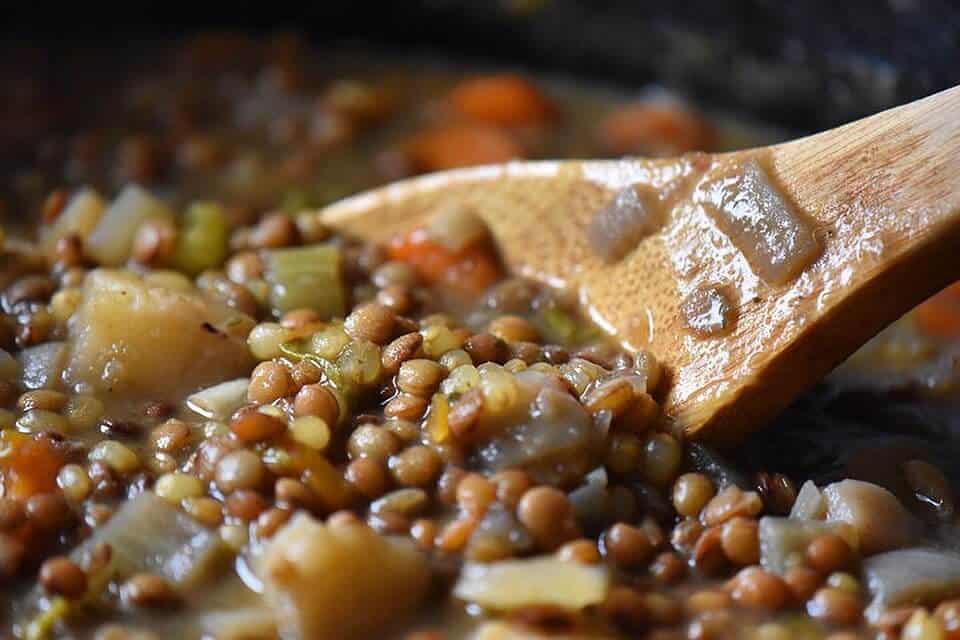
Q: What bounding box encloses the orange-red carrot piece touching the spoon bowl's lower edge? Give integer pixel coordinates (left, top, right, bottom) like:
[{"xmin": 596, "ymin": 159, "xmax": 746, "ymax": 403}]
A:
[{"xmin": 387, "ymin": 229, "xmax": 503, "ymax": 294}]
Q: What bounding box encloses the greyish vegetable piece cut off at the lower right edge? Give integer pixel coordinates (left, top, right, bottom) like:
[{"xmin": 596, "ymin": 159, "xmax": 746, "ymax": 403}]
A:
[{"xmin": 863, "ymin": 548, "xmax": 960, "ymax": 617}]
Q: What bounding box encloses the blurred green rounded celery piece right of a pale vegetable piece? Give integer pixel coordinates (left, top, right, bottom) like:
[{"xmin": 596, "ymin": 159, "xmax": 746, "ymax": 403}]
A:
[{"xmin": 173, "ymin": 202, "xmax": 230, "ymax": 275}]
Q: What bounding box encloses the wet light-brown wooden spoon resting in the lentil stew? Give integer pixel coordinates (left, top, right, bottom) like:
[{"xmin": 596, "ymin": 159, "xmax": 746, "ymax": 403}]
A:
[{"xmin": 324, "ymin": 87, "xmax": 960, "ymax": 442}]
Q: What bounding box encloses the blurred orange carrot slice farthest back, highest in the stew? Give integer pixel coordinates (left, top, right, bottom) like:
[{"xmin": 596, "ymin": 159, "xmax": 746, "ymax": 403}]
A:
[{"xmin": 449, "ymin": 73, "xmax": 556, "ymax": 127}]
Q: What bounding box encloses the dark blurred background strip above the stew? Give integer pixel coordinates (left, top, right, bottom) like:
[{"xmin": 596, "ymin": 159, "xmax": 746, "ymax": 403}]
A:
[{"xmin": 0, "ymin": 0, "xmax": 960, "ymax": 129}]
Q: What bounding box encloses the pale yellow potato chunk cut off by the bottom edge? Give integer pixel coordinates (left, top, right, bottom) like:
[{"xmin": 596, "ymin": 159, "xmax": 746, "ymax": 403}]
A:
[{"xmin": 259, "ymin": 514, "xmax": 430, "ymax": 640}]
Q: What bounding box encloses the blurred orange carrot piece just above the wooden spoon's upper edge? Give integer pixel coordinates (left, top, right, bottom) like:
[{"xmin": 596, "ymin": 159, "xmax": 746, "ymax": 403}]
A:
[{"xmin": 600, "ymin": 104, "xmax": 717, "ymax": 155}]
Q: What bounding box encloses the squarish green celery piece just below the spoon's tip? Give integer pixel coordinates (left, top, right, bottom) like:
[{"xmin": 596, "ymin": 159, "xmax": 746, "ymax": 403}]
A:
[{"xmin": 266, "ymin": 245, "xmax": 346, "ymax": 320}]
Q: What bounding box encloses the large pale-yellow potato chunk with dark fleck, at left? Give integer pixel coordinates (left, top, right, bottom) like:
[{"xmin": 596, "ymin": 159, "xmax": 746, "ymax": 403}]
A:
[{"xmin": 65, "ymin": 270, "xmax": 253, "ymax": 400}]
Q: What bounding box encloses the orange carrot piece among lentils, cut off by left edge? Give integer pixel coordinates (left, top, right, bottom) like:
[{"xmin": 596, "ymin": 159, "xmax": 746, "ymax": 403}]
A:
[{"xmin": 0, "ymin": 430, "xmax": 66, "ymax": 500}]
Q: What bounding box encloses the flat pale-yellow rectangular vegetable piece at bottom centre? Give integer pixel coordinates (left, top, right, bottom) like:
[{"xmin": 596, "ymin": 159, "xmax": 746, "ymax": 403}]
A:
[{"xmin": 453, "ymin": 557, "xmax": 610, "ymax": 611}]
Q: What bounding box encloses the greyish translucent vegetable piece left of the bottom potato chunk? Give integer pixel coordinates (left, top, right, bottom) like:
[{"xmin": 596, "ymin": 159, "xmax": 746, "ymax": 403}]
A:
[{"xmin": 73, "ymin": 491, "xmax": 229, "ymax": 588}]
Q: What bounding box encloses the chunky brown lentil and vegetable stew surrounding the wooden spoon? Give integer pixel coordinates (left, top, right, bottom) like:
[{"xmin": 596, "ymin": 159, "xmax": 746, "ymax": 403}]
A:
[{"xmin": 0, "ymin": 37, "xmax": 960, "ymax": 640}]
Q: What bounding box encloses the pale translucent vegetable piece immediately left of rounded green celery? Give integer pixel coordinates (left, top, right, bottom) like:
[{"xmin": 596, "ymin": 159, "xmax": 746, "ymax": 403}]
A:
[{"xmin": 87, "ymin": 184, "xmax": 173, "ymax": 267}]
